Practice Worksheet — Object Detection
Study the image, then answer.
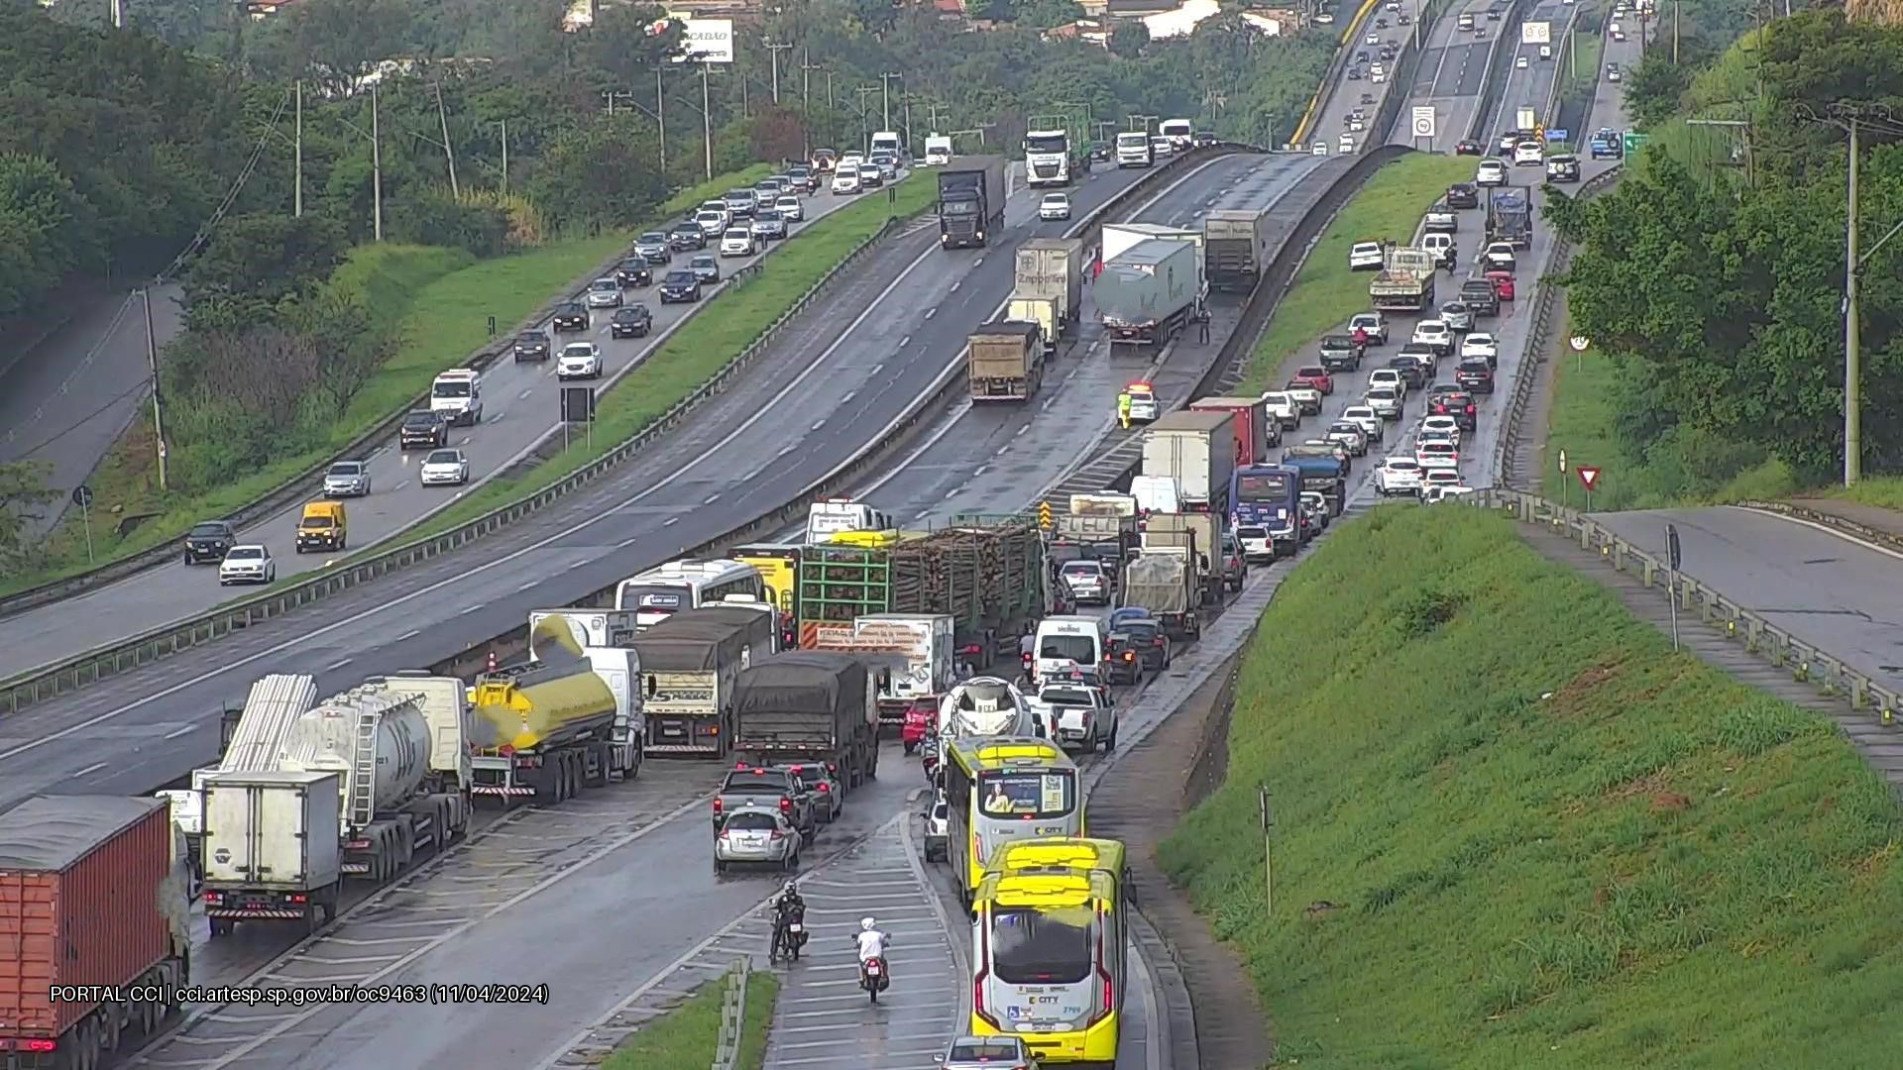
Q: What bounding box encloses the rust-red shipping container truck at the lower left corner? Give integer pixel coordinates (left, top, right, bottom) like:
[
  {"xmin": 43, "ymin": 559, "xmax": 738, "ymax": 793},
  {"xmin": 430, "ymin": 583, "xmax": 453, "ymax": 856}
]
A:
[{"xmin": 0, "ymin": 796, "xmax": 185, "ymax": 1038}]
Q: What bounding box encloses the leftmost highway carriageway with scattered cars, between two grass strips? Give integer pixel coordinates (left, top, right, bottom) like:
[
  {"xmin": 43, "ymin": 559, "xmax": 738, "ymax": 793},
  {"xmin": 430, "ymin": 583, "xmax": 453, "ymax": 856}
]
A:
[{"xmin": 0, "ymin": 192, "xmax": 881, "ymax": 678}]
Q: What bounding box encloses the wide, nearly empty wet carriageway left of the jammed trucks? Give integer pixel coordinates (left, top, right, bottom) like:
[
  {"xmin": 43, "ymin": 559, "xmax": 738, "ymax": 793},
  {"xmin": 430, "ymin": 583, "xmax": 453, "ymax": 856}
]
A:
[{"xmin": 0, "ymin": 152, "xmax": 1235, "ymax": 805}]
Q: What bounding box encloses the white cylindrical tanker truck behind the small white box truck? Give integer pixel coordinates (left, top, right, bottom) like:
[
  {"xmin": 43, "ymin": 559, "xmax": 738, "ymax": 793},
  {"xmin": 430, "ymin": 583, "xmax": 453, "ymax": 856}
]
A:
[{"xmin": 278, "ymin": 682, "xmax": 470, "ymax": 883}]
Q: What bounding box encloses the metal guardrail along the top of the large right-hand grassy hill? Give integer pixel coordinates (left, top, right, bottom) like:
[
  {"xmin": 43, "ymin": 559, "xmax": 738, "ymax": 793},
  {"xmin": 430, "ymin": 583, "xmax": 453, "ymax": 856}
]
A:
[{"xmin": 1473, "ymin": 487, "xmax": 1903, "ymax": 725}]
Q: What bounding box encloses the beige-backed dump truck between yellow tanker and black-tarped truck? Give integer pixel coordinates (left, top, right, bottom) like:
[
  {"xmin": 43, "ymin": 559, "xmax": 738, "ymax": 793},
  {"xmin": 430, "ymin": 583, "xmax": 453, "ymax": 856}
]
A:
[{"xmin": 634, "ymin": 605, "xmax": 778, "ymax": 758}]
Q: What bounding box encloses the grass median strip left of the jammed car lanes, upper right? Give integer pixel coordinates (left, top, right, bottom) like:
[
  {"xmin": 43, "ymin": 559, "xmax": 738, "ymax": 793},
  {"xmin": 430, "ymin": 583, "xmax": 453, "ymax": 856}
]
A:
[{"xmin": 1239, "ymin": 152, "xmax": 1473, "ymax": 392}]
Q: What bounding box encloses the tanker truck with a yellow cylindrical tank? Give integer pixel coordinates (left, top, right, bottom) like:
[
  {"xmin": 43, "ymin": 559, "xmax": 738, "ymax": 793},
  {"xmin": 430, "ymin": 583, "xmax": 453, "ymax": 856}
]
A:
[{"xmin": 470, "ymin": 617, "xmax": 618, "ymax": 805}]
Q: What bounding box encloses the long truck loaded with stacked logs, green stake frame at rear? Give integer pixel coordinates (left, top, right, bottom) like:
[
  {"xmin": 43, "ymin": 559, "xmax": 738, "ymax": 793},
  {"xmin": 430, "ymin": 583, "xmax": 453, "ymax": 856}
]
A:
[{"xmin": 799, "ymin": 516, "xmax": 1049, "ymax": 668}]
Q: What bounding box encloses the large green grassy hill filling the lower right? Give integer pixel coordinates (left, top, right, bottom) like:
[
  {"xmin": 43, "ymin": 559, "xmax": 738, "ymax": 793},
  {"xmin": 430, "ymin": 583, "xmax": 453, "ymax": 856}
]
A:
[{"xmin": 1161, "ymin": 506, "xmax": 1903, "ymax": 1070}]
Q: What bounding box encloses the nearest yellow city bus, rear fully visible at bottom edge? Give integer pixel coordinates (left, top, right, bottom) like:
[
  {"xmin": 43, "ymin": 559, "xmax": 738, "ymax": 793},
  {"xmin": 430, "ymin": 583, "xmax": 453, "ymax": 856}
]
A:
[{"xmin": 971, "ymin": 838, "xmax": 1128, "ymax": 1066}]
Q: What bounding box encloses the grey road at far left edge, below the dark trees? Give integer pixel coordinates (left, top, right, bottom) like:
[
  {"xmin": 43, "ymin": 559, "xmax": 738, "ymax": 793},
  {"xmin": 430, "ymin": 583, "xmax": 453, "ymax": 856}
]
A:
[{"xmin": 0, "ymin": 284, "xmax": 185, "ymax": 536}]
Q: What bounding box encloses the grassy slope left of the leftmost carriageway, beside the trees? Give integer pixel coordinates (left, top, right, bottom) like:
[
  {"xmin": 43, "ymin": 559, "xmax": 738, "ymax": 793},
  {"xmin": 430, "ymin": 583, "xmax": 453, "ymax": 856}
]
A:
[{"xmin": 0, "ymin": 166, "xmax": 771, "ymax": 594}]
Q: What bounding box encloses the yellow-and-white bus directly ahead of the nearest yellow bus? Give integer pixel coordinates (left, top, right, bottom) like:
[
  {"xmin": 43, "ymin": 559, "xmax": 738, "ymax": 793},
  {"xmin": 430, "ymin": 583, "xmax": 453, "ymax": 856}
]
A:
[{"xmin": 944, "ymin": 735, "xmax": 1083, "ymax": 906}]
